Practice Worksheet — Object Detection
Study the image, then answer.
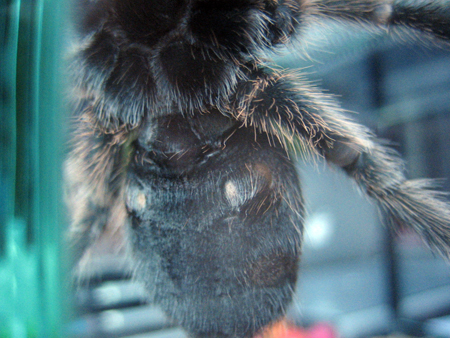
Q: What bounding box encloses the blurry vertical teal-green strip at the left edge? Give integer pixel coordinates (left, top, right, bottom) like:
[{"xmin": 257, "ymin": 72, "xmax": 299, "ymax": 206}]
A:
[{"xmin": 0, "ymin": 0, "xmax": 69, "ymax": 338}]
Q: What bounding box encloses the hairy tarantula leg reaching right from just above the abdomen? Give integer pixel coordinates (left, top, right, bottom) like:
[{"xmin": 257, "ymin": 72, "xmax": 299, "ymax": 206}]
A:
[{"xmin": 229, "ymin": 67, "xmax": 450, "ymax": 258}]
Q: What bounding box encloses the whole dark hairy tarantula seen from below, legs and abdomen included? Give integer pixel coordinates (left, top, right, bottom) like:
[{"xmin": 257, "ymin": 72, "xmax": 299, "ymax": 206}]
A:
[{"xmin": 66, "ymin": 0, "xmax": 450, "ymax": 338}]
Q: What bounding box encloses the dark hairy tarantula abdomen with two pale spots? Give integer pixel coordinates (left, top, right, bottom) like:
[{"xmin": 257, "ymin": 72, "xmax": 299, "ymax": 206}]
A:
[{"xmin": 125, "ymin": 111, "xmax": 303, "ymax": 338}]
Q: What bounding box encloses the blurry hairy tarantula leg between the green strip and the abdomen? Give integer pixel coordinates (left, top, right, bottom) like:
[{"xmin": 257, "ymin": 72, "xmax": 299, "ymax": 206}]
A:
[{"xmin": 64, "ymin": 103, "xmax": 133, "ymax": 278}]
